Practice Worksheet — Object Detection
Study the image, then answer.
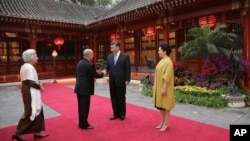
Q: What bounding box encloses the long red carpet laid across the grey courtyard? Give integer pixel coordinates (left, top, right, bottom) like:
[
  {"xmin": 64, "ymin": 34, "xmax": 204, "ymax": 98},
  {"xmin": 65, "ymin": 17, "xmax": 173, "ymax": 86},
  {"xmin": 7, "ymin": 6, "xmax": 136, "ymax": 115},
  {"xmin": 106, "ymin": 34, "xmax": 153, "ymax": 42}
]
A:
[{"xmin": 0, "ymin": 84, "xmax": 229, "ymax": 141}]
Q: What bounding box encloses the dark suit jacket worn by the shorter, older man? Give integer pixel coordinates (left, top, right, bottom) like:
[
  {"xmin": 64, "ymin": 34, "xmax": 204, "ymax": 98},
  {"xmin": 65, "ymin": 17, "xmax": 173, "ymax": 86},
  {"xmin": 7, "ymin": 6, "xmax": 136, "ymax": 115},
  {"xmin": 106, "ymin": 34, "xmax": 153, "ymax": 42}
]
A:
[{"xmin": 75, "ymin": 58, "xmax": 104, "ymax": 95}]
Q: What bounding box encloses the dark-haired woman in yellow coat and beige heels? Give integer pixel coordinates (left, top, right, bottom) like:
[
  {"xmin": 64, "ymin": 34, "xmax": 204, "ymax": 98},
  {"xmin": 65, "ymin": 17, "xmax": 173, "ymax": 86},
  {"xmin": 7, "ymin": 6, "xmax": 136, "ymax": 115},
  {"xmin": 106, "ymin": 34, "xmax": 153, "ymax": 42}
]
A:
[{"xmin": 152, "ymin": 43, "xmax": 175, "ymax": 131}]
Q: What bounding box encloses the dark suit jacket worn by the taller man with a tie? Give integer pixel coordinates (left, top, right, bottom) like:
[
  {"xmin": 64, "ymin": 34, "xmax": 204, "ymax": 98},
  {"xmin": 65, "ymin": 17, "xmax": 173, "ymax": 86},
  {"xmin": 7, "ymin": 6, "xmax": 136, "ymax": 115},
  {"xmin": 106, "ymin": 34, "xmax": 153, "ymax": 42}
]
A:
[{"xmin": 106, "ymin": 52, "xmax": 131, "ymax": 87}]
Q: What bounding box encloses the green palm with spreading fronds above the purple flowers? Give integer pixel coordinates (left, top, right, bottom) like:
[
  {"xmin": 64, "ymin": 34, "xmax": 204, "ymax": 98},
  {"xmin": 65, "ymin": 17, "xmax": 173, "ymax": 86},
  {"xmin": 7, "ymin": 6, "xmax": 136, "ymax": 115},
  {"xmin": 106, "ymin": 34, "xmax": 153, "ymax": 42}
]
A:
[{"xmin": 178, "ymin": 24, "xmax": 238, "ymax": 60}]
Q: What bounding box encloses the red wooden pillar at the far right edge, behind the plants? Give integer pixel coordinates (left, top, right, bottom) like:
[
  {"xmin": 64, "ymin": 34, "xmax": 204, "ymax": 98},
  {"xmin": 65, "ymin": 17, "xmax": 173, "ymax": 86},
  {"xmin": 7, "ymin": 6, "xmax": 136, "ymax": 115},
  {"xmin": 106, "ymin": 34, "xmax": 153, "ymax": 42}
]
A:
[{"xmin": 242, "ymin": 7, "xmax": 250, "ymax": 88}]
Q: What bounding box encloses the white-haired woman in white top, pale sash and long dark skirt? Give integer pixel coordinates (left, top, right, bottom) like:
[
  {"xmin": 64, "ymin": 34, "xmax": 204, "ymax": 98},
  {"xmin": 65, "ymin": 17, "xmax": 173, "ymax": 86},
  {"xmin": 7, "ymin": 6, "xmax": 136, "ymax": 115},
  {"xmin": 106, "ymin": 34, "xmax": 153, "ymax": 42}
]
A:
[{"xmin": 12, "ymin": 49, "xmax": 48, "ymax": 141}]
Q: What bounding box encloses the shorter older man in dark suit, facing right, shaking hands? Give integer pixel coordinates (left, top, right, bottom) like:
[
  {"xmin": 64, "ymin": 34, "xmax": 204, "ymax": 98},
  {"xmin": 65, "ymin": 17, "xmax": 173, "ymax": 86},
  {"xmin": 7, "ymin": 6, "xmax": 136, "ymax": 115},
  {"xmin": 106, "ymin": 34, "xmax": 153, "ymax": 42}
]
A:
[{"xmin": 75, "ymin": 49, "xmax": 106, "ymax": 129}]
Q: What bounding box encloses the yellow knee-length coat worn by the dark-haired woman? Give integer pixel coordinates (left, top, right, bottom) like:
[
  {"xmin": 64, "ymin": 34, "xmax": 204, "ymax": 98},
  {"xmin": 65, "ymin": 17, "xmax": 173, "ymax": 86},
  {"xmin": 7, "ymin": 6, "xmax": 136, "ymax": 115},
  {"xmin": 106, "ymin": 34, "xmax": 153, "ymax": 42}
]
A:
[{"xmin": 152, "ymin": 57, "xmax": 175, "ymax": 110}]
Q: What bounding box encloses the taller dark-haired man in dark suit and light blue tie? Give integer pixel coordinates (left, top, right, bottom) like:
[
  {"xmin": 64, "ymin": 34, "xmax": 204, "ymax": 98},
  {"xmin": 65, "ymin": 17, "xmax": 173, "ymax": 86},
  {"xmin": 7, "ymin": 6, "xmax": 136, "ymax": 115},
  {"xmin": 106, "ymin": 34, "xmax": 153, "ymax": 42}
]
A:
[{"xmin": 106, "ymin": 41, "xmax": 131, "ymax": 120}]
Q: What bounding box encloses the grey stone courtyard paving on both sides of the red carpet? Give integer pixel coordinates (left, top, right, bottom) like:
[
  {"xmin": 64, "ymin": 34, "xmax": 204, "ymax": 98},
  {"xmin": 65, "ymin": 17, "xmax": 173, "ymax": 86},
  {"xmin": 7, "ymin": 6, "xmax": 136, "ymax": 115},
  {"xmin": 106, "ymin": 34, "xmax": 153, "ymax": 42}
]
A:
[{"xmin": 0, "ymin": 80, "xmax": 250, "ymax": 129}]
